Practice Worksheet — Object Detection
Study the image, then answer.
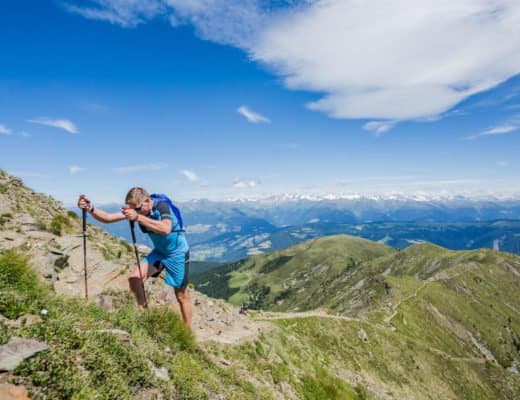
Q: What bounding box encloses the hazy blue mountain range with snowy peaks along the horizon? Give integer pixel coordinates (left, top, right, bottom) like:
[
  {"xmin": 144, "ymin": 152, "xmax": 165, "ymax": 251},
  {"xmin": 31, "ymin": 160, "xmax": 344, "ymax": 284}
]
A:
[{"xmin": 76, "ymin": 196, "xmax": 520, "ymax": 262}]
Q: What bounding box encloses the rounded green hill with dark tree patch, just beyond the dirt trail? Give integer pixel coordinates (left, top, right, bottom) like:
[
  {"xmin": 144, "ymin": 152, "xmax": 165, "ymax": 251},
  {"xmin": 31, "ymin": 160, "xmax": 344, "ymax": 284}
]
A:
[{"xmin": 194, "ymin": 235, "xmax": 396, "ymax": 310}]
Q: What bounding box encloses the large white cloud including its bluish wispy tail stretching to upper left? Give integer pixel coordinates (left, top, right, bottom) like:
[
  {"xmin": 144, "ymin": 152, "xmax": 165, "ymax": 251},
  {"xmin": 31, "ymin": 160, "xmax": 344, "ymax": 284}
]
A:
[{"xmin": 69, "ymin": 0, "xmax": 520, "ymax": 120}]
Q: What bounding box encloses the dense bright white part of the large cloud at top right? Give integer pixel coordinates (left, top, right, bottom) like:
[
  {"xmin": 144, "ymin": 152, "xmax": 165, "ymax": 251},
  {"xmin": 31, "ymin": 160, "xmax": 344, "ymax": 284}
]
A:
[{"xmin": 252, "ymin": 0, "xmax": 520, "ymax": 119}]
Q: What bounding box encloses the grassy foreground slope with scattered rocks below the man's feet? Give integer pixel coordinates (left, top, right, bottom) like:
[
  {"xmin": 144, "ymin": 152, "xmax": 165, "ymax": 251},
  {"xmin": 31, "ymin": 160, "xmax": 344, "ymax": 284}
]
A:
[{"xmin": 0, "ymin": 251, "xmax": 284, "ymax": 400}]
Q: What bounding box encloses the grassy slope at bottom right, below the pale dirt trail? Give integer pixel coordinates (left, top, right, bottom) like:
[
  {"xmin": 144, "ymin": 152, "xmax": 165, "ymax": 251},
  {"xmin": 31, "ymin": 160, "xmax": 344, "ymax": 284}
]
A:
[{"xmin": 223, "ymin": 311, "xmax": 520, "ymax": 400}]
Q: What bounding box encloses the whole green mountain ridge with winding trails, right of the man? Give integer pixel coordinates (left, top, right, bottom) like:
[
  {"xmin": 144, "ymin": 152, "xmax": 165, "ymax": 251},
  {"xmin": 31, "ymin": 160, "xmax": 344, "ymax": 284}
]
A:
[{"xmin": 194, "ymin": 237, "xmax": 520, "ymax": 399}]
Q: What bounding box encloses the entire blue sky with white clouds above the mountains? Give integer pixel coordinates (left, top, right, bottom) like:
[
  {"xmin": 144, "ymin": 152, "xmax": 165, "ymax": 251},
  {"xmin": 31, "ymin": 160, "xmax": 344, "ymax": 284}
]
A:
[{"xmin": 0, "ymin": 0, "xmax": 520, "ymax": 203}]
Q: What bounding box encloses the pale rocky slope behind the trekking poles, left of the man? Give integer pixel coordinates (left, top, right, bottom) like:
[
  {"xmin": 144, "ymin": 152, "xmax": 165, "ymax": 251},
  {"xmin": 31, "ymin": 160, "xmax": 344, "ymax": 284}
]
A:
[{"xmin": 0, "ymin": 170, "xmax": 135, "ymax": 296}]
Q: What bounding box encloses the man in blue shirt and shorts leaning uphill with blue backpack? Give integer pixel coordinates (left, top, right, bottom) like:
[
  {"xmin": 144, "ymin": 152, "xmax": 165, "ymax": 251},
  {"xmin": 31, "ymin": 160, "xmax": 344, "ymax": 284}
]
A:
[{"xmin": 78, "ymin": 187, "xmax": 191, "ymax": 326}]
